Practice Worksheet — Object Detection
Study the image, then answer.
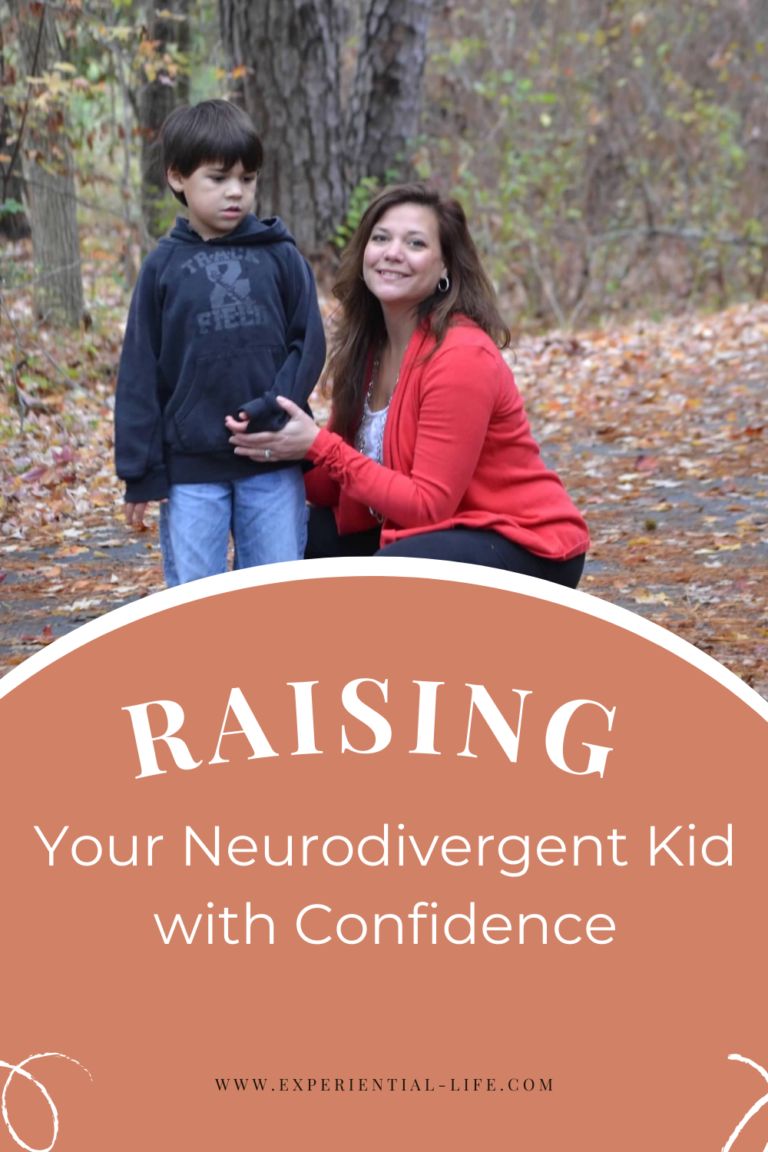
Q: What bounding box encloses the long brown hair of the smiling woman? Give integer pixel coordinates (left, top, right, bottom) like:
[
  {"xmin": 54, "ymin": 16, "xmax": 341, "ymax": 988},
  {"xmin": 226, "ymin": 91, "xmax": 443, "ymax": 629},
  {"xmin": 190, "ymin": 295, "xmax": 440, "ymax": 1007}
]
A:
[{"xmin": 322, "ymin": 183, "xmax": 511, "ymax": 444}]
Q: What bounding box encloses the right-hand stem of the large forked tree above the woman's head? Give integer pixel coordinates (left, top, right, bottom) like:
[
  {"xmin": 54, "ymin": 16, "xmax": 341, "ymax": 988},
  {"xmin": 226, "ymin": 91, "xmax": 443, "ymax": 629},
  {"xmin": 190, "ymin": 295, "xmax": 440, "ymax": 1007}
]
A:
[{"xmin": 345, "ymin": 0, "xmax": 432, "ymax": 189}]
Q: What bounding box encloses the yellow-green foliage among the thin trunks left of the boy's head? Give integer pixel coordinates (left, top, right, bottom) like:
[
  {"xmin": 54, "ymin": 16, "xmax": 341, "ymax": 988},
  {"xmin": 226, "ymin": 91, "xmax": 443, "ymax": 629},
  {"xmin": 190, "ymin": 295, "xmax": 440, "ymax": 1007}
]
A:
[{"xmin": 0, "ymin": 0, "xmax": 221, "ymax": 276}]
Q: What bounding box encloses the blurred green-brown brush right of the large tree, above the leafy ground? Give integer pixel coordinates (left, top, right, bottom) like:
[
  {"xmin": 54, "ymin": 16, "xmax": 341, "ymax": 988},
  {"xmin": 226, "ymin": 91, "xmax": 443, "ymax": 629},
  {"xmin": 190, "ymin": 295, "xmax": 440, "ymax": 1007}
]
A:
[{"xmin": 423, "ymin": 0, "xmax": 768, "ymax": 324}]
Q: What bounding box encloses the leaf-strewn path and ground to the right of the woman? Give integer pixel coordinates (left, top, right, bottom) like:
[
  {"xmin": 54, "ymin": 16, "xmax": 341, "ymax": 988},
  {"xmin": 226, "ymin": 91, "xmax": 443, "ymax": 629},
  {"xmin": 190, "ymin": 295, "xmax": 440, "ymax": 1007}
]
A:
[{"xmin": 517, "ymin": 304, "xmax": 768, "ymax": 696}]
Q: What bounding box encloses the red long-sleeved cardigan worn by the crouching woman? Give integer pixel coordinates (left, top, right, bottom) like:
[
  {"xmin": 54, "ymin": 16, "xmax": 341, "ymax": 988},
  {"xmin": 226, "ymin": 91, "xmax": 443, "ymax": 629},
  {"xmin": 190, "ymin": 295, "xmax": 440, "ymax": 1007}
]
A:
[{"xmin": 305, "ymin": 320, "xmax": 590, "ymax": 560}]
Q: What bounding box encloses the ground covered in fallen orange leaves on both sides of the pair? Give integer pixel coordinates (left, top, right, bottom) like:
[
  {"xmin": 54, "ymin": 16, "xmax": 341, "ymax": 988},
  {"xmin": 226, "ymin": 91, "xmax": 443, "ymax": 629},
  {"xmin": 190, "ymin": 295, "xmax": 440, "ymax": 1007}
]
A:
[{"xmin": 0, "ymin": 240, "xmax": 768, "ymax": 697}]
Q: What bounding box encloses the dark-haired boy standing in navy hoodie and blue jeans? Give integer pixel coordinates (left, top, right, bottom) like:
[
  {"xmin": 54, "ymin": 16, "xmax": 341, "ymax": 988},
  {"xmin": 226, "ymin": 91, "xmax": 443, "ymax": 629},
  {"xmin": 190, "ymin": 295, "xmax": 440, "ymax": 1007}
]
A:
[{"xmin": 115, "ymin": 100, "xmax": 325, "ymax": 588}]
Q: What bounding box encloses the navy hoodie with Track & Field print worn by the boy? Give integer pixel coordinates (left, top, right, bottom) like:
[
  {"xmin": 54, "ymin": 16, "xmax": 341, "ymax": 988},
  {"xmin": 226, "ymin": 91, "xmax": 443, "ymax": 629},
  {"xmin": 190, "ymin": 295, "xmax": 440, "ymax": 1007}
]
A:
[{"xmin": 115, "ymin": 215, "xmax": 326, "ymax": 503}]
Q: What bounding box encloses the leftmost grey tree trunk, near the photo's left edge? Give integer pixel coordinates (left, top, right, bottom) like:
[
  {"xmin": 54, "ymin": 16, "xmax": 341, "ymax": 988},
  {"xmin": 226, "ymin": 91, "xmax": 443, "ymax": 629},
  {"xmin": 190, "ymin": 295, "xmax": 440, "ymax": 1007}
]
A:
[{"xmin": 10, "ymin": 0, "xmax": 83, "ymax": 327}]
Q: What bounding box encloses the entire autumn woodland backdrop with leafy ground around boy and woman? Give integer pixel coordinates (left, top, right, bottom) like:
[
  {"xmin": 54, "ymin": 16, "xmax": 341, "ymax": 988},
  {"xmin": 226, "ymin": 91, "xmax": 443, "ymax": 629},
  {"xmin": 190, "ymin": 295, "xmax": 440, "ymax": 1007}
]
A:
[{"xmin": 0, "ymin": 0, "xmax": 768, "ymax": 695}]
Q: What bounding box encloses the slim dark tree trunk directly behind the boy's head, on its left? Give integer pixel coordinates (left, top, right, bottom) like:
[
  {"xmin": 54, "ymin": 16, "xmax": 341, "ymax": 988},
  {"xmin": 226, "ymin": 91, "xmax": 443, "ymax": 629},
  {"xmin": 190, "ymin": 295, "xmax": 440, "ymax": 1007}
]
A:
[{"xmin": 138, "ymin": 0, "xmax": 190, "ymax": 240}]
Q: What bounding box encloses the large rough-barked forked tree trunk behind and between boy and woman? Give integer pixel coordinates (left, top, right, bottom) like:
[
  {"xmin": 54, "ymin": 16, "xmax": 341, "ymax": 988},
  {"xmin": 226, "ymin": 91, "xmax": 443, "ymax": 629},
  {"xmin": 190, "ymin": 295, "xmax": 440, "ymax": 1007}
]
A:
[{"xmin": 219, "ymin": 0, "xmax": 429, "ymax": 252}]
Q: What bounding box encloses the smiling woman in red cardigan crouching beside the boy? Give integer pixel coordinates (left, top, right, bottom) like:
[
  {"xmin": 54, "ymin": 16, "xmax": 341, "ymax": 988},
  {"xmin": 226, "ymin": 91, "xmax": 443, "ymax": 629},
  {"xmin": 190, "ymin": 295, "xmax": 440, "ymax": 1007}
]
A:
[{"xmin": 227, "ymin": 183, "xmax": 590, "ymax": 588}]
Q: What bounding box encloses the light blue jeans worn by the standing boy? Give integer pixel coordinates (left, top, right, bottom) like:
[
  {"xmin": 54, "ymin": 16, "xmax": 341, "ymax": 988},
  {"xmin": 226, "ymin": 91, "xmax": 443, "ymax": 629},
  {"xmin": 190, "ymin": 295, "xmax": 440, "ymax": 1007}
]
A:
[{"xmin": 160, "ymin": 468, "xmax": 306, "ymax": 588}]
